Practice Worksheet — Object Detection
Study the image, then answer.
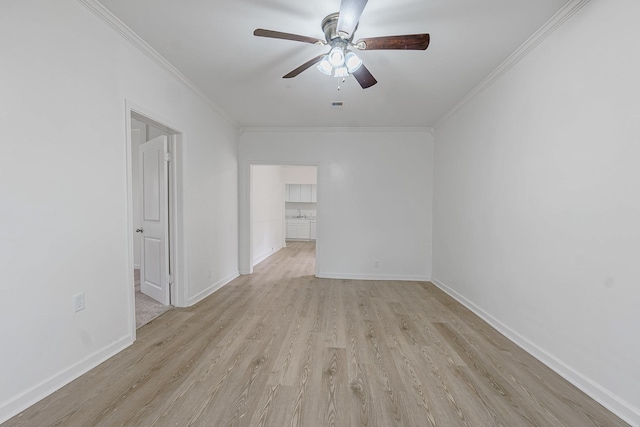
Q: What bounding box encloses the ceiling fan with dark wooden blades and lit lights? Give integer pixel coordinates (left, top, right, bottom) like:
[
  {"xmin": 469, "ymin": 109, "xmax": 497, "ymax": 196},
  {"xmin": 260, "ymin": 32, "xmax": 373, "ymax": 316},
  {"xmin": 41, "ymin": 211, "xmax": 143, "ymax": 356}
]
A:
[{"xmin": 253, "ymin": 0, "xmax": 429, "ymax": 89}]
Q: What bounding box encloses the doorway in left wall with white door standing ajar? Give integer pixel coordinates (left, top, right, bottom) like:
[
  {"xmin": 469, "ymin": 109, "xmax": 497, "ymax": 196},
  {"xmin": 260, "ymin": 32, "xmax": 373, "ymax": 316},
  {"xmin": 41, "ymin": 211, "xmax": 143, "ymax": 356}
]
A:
[{"xmin": 127, "ymin": 106, "xmax": 183, "ymax": 336}]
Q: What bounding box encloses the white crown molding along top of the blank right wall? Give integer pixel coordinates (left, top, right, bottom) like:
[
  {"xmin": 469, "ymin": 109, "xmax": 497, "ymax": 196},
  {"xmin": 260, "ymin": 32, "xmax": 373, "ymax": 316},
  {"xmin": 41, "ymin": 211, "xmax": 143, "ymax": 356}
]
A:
[{"xmin": 433, "ymin": 0, "xmax": 589, "ymax": 130}]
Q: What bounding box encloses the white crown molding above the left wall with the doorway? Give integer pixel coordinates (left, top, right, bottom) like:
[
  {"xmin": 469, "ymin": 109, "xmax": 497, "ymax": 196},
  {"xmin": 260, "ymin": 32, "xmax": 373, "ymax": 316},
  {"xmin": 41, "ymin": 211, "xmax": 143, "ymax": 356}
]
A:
[{"xmin": 77, "ymin": 0, "xmax": 240, "ymax": 130}]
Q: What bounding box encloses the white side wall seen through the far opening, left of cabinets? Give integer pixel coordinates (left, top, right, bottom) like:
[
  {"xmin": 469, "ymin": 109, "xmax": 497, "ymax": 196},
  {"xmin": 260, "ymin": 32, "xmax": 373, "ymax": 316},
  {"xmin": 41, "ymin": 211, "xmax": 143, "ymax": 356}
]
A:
[{"xmin": 251, "ymin": 165, "xmax": 284, "ymax": 265}]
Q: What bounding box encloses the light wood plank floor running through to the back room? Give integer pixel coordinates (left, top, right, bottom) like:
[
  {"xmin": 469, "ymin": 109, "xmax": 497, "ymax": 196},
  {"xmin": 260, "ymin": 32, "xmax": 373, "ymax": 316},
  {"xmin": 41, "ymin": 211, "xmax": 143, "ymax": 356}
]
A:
[{"xmin": 6, "ymin": 242, "xmax": 626, "ymax": 427}]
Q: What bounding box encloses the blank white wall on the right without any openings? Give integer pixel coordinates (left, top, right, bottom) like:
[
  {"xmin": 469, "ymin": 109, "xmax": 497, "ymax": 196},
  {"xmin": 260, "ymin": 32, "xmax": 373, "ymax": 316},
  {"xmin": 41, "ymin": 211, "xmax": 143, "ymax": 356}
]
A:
[{"xmin": 433, "ymin": 0, "xmax": 640, "ymax": 425}]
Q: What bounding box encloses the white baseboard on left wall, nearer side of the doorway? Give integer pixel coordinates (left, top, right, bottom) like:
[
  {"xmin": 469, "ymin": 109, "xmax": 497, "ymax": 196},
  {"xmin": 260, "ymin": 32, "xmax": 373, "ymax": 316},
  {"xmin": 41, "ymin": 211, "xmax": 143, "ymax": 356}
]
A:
[{"xmin": 0, "ymin": 335, "xmax": 133, "ymax": 424}]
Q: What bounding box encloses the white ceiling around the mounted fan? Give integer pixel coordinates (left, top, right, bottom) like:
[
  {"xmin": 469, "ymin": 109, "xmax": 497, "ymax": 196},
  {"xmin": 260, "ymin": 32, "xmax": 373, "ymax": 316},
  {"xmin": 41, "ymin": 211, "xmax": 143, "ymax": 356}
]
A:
[{"xmin": 99, "ymin": 0, "xmax": 569, "ymax": 128}]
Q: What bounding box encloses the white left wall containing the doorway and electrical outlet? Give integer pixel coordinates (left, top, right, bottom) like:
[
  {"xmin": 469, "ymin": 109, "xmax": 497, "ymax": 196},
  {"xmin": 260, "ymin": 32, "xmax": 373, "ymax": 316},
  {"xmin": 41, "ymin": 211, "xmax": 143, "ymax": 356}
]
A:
[{"xmin": 0, "ymin": 0, "xmax": 238, "ymax": 421}]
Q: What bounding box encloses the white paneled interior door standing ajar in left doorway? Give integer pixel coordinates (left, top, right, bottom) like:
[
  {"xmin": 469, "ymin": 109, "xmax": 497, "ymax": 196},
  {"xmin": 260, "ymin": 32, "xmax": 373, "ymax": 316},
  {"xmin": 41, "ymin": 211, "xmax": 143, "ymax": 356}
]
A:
[{"xmin": 139, "ymin": 135, "xmax": 170, "ymax": 305}]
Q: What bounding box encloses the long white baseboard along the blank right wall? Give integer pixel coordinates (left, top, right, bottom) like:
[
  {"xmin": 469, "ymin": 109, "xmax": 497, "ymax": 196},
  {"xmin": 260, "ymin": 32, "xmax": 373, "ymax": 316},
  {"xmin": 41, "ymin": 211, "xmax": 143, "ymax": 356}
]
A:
[{"xmin": 431, "ymin": 278, "xmax": 640, "ymax": 426}]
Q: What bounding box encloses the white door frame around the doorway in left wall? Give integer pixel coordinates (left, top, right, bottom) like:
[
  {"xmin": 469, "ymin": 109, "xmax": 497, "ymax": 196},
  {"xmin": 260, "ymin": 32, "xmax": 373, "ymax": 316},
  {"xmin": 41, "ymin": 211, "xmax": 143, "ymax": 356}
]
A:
[{"xmin": 125, "ymin": 100, "xmax": 188, "ymax": 340}]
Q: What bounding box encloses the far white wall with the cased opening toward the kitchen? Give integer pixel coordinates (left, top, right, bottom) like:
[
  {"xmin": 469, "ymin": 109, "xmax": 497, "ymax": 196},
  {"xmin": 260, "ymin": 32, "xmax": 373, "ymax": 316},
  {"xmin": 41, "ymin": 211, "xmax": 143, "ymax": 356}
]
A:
[{"xmin": 240, "ymin": 129, "xmax": 433, "ymax": 280}]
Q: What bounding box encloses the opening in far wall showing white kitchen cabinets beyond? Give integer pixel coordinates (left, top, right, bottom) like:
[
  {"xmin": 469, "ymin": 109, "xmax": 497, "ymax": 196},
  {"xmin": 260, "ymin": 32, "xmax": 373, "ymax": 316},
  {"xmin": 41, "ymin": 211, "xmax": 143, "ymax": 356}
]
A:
[{"xmin": 250, "ymin": 165, "xmax": 318, "ymax": 266}]
